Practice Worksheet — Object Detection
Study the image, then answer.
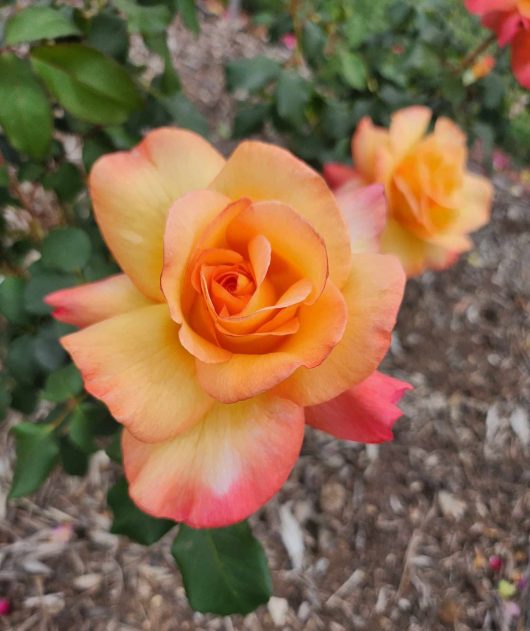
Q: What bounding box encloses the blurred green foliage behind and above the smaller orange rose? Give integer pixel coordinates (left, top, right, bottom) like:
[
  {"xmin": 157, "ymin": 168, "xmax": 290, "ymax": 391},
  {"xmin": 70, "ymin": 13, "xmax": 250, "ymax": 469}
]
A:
[{"xmin": 233, "ymin": 0, "xmax": 530, "ymax": 166}]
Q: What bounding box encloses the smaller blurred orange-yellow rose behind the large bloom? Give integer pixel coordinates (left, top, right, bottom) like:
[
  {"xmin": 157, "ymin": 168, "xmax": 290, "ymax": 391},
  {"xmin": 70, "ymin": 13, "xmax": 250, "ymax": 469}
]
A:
[{"xmin": 324, "ymin": 106, "xmax": 493, "ymax": 276}]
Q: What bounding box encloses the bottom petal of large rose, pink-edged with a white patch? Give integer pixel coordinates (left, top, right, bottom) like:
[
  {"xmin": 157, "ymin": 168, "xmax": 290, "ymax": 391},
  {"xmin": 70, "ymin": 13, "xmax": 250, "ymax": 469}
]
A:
[{"xmin": 122, "ymin": 397, "xmax": 304, "ymax": 528}]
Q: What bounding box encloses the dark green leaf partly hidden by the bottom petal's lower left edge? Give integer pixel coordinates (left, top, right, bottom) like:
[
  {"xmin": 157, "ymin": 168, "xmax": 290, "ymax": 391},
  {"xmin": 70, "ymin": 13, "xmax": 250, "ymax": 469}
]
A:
[{"xmin": 107, "ymin": 478, "xmax": 175, "ymax": 546}]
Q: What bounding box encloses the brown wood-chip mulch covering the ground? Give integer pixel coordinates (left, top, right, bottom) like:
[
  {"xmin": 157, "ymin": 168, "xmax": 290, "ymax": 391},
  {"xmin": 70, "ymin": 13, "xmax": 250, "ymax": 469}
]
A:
[{"xmin": 0, "ymin": 9, "xmax": 530, "ymax": 631}]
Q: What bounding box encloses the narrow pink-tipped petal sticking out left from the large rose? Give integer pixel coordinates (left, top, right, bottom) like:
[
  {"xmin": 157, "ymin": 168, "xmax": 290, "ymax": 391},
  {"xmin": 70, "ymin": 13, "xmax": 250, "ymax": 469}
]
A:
[{"xmin": 44, "ymin": 274, "xmax": 152, "ymax": 327}]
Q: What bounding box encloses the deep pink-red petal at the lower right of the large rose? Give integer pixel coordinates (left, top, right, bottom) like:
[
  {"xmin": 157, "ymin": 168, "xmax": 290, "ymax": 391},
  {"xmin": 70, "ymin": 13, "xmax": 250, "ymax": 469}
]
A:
[{"xmin": 305, "ymin": 371, "xmax": 412, "ymax": 443}]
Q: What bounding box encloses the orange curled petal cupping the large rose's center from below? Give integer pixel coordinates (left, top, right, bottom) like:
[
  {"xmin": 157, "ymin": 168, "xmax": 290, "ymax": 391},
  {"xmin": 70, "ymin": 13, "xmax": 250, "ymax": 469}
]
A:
[{"xmin": 197, "ymin": 282, "xmax": 346, "ymax": 403}]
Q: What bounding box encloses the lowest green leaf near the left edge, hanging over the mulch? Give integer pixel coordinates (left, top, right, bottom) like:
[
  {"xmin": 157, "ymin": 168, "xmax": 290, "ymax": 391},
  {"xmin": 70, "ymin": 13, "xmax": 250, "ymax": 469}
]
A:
[{"xmin": 9, "ymin": 423, "xmax": 59, "ymax": 498}]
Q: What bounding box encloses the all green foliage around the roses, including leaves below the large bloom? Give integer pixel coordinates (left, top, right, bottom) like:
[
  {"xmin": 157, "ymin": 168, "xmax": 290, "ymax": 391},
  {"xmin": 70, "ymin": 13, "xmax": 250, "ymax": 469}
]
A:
[{"xmin": 0, "ymin": 0, "xmax": 530, "ymax": 614}]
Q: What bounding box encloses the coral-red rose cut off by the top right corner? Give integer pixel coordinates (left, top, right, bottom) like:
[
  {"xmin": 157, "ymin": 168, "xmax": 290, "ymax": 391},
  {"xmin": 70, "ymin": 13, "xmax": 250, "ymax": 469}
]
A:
[{"xmin": 466, "ymin": 0, "xmax": 530, "ymax": 89}]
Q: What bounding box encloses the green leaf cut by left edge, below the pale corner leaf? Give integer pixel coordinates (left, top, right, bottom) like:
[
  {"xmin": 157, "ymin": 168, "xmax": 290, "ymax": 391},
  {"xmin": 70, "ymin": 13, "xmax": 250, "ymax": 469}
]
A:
[{"xmin": 0, "ymin": 53, "xmax": 53, "ymax": 160}]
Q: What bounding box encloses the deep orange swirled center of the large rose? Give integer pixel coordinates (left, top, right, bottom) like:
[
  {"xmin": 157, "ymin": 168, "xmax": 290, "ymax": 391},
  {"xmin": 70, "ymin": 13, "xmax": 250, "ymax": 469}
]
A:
[{"xmin": 181, "ymin": 199, "xmax": 327, "ymax": 353}]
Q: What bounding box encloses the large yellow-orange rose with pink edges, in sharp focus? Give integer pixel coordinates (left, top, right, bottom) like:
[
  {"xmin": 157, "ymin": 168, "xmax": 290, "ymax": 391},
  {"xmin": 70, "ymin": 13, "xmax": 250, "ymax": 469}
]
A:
[{"xmin": 47, "ymin": 128, "xmax": 409, "ymax": 527}]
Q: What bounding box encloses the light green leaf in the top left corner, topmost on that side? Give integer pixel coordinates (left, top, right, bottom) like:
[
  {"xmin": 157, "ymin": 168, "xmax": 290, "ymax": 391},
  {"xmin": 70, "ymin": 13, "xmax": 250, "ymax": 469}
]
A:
[{"xmin": 4, "ymin": 6, "xmax": 80, "ymax": 46}]
